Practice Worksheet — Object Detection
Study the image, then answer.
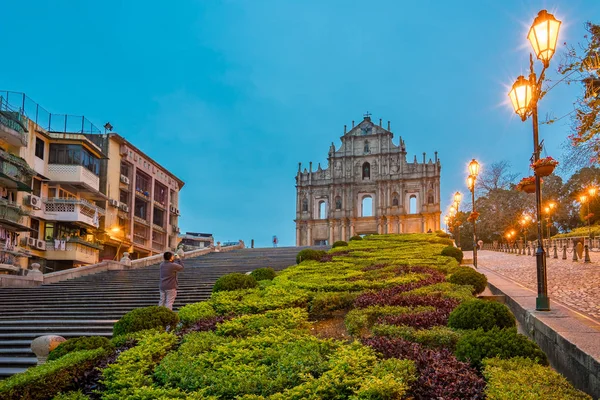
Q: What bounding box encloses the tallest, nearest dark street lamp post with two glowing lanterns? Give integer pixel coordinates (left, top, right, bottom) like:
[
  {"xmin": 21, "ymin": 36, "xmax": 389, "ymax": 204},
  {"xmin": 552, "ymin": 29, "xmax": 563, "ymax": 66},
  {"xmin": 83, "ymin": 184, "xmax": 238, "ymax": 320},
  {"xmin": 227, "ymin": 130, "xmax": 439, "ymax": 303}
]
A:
[{"xmin": 508, "ymin": 10, "xmax": 561, "ymax": 311}]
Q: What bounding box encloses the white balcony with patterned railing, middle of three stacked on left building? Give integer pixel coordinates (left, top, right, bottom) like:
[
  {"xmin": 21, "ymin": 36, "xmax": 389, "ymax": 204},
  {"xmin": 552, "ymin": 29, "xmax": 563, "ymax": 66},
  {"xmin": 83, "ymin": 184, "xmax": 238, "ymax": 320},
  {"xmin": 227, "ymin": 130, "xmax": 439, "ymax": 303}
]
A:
[{"xmin": 43, "ymin": 199, "xmax": 106, "ymax": 228}]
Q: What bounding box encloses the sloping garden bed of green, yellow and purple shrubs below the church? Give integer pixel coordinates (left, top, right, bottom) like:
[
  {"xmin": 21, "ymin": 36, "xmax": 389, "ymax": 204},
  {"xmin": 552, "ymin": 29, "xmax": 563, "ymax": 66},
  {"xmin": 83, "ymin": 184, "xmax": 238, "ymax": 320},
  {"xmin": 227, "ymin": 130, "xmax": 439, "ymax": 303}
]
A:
[{"xmin": 0, "ymin": 234, "xmax": 590, "ymax": 400}]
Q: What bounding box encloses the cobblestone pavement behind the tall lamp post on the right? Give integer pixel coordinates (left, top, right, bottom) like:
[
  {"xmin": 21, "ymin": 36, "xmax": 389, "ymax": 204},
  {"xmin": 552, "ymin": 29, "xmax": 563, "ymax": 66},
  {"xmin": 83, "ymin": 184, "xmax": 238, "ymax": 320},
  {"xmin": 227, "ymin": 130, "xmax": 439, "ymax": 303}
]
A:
[{"xmin": 476, "ymin": 250, "xmax": 600, "ymax": 321}]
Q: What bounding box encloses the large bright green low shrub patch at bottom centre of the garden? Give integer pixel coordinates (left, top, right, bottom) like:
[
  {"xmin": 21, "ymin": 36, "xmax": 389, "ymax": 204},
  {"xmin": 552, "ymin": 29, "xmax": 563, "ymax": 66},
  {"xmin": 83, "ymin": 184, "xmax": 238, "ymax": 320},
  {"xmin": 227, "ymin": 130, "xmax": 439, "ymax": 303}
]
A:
[{"xmin": 154, "ymin": 327, "xmax": 415, "ymax": 400}]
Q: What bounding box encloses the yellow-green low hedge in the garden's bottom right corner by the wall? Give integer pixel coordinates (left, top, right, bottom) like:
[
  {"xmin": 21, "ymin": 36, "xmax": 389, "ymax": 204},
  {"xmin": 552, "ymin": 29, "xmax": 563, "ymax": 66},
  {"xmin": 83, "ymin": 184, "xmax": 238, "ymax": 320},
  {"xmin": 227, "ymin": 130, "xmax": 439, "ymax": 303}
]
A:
[{"xmin": 483, "ymin": 357, "xmax": 592, "ymax": 400}]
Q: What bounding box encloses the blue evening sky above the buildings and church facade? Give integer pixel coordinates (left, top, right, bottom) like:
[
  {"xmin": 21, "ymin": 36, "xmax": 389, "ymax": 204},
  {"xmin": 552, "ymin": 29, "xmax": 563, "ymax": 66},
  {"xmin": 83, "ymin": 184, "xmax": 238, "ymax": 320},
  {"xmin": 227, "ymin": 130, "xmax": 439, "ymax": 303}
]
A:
[{"xmin": 0, "ymin": 0, "xmax": 600, "ymax": 246}]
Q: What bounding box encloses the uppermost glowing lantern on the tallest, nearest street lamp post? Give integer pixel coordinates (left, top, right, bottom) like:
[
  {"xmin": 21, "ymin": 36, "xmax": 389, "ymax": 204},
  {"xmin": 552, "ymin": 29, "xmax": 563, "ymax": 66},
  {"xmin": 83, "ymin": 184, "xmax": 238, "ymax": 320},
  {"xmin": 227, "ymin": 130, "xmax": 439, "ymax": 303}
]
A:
[{"xmin": 527, "ymin": 10, "xmax": 561, "ymax": 68}]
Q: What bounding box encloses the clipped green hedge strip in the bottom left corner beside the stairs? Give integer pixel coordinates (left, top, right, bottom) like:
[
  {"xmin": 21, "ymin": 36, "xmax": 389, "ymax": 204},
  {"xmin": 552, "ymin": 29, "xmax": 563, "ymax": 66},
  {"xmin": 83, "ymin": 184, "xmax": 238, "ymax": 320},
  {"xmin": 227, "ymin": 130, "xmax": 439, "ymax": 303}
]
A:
[{"xmin": 0, "ymin": 349, "xmax": 107, "ymax": 400}]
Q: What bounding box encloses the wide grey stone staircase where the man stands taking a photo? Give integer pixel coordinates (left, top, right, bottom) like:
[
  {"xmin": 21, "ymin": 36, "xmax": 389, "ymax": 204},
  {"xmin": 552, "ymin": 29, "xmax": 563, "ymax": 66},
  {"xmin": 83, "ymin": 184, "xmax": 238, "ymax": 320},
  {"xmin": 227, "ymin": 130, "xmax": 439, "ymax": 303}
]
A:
[{"xmin": 0, "ymin": 247, "xmax": 310, "ymax": 379}]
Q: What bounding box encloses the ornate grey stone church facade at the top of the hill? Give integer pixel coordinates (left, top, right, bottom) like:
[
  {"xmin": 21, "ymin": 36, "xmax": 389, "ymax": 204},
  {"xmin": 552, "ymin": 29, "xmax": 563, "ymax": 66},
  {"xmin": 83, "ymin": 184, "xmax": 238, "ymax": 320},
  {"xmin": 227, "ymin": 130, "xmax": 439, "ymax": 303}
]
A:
[{"xmin": 295, "ymin": 114, "xmax": 441, "ymax": 246}]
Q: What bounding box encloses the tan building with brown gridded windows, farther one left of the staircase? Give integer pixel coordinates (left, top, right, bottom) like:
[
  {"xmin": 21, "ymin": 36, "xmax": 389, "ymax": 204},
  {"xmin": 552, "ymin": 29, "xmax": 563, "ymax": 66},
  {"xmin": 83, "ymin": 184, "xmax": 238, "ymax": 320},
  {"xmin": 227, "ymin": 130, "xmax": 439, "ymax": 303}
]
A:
[{"xmin": 88, "ymin": 132, "xmax": 184, "ymax": 259}]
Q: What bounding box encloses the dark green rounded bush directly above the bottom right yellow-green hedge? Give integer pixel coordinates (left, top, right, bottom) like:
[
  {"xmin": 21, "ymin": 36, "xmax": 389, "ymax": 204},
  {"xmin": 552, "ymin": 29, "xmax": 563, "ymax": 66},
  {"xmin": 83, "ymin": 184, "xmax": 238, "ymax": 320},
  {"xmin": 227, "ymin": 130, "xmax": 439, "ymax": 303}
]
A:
[{"xmin": 455, "ymin": 328, "xmax": 548, "ymax": 368}]
